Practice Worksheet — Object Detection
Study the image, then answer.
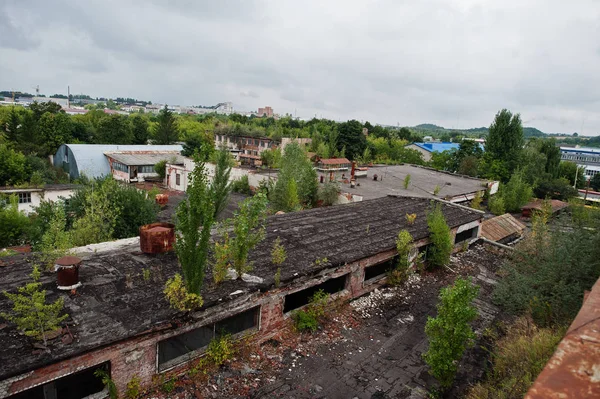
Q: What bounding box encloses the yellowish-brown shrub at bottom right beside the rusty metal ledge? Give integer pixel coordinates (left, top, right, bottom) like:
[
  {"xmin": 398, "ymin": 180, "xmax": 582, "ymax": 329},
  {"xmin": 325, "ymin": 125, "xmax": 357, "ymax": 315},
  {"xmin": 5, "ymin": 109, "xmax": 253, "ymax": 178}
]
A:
[{"xmin": 467, "ymin": 317, "xmax": 564, "ymax": 399}]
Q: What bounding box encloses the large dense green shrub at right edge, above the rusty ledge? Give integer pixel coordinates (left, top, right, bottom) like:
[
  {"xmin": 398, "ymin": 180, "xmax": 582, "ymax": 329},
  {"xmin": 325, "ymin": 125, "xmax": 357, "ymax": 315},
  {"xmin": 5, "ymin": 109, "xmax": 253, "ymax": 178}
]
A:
[{"xmin": 494, "ymin": 219, "xmax": 600, "ymax": 327}]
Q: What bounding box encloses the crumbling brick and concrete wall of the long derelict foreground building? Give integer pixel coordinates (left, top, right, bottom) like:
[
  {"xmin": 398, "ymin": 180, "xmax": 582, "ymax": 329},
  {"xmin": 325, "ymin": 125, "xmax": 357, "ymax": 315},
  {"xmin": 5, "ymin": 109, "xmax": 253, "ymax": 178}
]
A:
[{"xmin": 0, "ymin": 221, "xmax": 479, "ymax": 398}]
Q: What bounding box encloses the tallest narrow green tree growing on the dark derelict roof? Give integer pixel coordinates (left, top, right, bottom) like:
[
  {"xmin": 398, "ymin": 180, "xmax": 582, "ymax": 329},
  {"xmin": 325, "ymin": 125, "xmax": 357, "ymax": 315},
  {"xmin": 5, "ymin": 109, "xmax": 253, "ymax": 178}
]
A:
[{"xmin": 175, "ymin": 158, "xmax": 215, "ymax": 295}]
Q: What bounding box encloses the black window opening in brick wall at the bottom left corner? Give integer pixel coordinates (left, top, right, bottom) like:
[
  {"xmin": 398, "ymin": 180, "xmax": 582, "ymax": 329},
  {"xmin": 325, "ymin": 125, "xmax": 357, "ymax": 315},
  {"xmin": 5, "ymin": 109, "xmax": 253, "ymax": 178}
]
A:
[{"xmin": 7, "ymin": 362, "xmax": 110, "ymax": 399}]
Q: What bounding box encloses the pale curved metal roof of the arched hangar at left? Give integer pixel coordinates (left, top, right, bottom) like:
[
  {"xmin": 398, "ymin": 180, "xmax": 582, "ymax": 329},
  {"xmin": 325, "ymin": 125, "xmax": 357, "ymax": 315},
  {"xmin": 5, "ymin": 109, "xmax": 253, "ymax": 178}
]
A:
[{"xmin": 58, "ymin": 144, "xmax": 182, "ymax": 178}]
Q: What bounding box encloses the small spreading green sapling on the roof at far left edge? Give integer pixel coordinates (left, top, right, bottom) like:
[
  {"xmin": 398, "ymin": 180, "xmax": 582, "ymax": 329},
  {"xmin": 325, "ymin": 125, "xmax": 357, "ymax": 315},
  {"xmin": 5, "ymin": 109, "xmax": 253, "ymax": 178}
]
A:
[{"xmin": 0, "ymin": 267, "xmax": 69, "ymax": 346}]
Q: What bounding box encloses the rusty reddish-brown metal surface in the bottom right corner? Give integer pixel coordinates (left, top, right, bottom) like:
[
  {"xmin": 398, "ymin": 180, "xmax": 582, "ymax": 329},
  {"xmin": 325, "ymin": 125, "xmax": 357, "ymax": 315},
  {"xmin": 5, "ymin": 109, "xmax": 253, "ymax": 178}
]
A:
[{"xmin": 525, "ymin": 279, "xmax": 600, "ymax": 399}]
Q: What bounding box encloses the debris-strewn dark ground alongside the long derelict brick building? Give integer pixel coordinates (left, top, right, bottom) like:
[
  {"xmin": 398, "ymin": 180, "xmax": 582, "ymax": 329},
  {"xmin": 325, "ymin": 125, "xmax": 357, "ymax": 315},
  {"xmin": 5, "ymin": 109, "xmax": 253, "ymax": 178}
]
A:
[{"xmin": 145, "ymin": 245, "xmax": 504, "ymax": 399}]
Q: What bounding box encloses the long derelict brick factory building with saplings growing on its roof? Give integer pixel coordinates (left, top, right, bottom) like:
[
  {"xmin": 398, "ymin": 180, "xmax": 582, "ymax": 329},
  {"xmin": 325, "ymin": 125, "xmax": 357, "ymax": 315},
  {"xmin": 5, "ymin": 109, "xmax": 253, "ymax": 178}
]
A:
[{"xmin": 0, "ymin": 196, "xmax": 483, "ymax": 399}]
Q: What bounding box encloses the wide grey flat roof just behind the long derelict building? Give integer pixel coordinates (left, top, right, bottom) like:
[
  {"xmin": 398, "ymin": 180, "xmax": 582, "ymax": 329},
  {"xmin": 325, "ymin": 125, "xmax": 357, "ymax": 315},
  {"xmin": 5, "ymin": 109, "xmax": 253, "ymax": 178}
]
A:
[{"xmin": 332, "ymin": 164, "xmax": 489, "ymax": 200}]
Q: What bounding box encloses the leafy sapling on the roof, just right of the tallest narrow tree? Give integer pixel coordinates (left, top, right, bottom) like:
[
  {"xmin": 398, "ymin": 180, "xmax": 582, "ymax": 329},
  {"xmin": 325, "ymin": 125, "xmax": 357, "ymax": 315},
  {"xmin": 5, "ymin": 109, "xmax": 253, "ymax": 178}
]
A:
[{"xmin": 230, "ymin": 193, "xmax": 267, "ymax": 279}]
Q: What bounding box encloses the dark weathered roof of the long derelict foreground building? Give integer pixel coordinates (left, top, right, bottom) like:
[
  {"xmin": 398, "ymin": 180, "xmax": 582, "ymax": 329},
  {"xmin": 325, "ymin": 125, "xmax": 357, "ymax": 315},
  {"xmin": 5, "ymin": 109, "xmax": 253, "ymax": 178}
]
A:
[{"xmin": 0, "ymin": 196, "xmax": 482, "ymax": 380}]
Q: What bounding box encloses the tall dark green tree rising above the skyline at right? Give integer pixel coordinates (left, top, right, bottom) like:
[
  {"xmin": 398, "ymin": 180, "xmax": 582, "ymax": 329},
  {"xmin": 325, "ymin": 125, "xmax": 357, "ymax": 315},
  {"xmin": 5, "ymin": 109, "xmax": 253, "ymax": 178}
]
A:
[{"xmin": 484, "ymin": 109, "xmax": 524, "ymax": 182}]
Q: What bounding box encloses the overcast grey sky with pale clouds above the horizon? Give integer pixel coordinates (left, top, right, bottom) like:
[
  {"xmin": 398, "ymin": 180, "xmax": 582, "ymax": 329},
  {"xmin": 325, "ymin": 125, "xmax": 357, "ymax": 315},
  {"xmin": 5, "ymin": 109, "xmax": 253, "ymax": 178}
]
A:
[{"xmin": 0, "ymin": 0, "xmax": 600, "ymax": 135}]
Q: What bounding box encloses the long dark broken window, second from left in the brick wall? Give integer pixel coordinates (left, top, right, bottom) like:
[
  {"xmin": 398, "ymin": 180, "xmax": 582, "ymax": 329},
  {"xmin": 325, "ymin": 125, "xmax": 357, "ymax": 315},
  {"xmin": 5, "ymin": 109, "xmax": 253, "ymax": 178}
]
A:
[{"xmin": 158, "ymin": 306, "xmax": 260, "ymax": 371}]
